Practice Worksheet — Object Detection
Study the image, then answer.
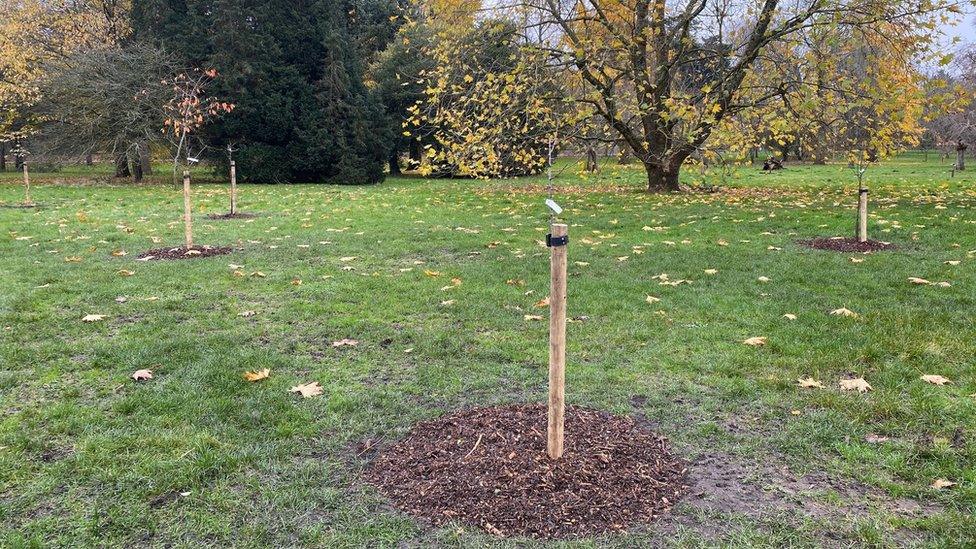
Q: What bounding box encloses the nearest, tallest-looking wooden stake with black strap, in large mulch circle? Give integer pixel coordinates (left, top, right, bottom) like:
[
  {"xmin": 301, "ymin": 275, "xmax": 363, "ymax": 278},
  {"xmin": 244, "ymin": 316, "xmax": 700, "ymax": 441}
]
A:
[{"xmin": 546, "ymin": 223, "xmax": 568, "ymax": 459}]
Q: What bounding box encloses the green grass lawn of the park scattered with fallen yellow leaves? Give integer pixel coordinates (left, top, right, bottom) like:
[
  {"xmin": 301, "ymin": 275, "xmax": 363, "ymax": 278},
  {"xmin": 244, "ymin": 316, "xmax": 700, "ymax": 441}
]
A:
[{"xmin": 0, "ymin": 155, "xmax": 976, "ymax": 547}]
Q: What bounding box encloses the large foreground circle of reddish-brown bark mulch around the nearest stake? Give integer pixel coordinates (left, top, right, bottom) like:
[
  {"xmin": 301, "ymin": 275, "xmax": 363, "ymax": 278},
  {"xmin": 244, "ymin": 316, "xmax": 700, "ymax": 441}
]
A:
[{"xmin": 365, "ymin": 404, "xmax": 687, "ymax": 539}]
